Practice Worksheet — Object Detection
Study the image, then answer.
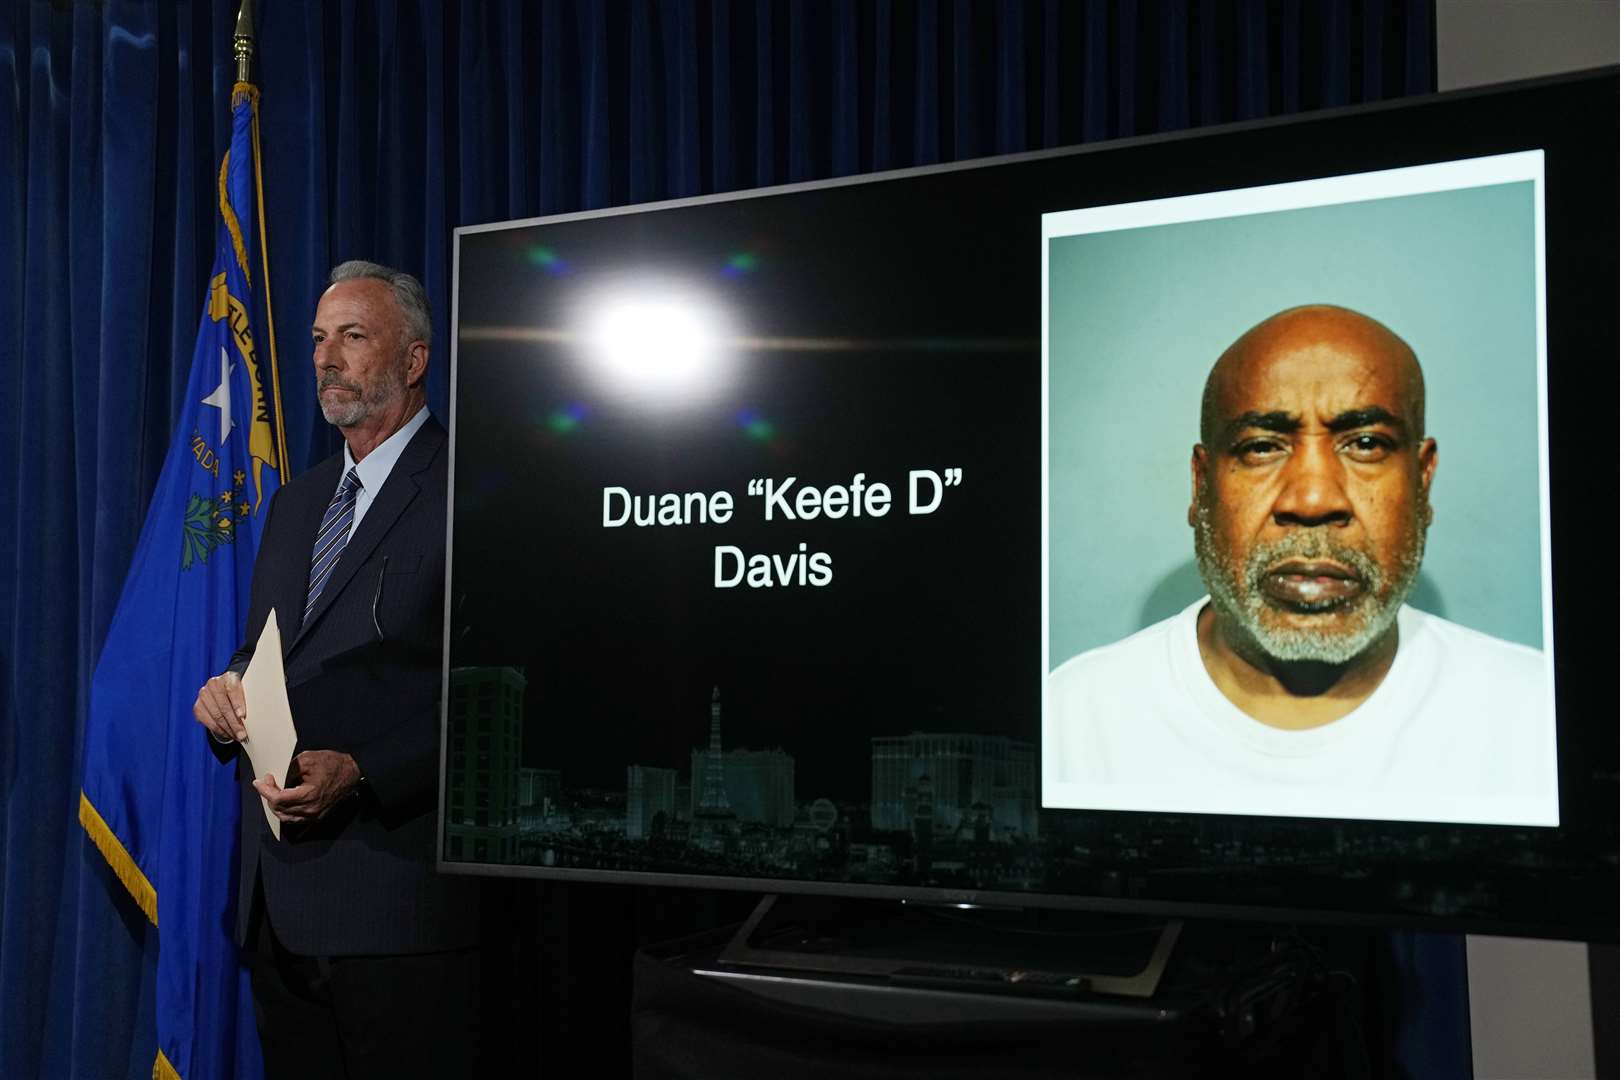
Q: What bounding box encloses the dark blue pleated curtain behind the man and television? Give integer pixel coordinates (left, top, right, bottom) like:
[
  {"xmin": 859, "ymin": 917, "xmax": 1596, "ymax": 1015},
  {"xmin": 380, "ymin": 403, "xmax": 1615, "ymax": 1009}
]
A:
[{"xmin": 0, "ymin": 0, "xmax": 1445, "ymax": 1080}]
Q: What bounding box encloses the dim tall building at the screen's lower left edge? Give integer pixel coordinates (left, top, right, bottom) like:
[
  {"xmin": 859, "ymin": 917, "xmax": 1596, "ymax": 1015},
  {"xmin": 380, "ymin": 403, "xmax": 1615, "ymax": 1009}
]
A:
[{"xmin": 444, "ymin": 667, "xmax": 528, "ymax": 863}]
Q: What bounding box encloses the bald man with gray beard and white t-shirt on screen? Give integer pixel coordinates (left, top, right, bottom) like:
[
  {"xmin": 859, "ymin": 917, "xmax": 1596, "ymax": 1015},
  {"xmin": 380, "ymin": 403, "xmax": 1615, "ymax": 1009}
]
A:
[{"xmin": 1048, "ymin": 304, "xmax": 1557, "ymax": 824}]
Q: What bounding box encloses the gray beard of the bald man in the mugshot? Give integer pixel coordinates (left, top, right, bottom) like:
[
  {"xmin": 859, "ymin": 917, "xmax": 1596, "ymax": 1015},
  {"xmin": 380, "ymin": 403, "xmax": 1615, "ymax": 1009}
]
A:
[{"xmin": 1194, "ymin": 500, "xmax": 1426, "ymax": 664}]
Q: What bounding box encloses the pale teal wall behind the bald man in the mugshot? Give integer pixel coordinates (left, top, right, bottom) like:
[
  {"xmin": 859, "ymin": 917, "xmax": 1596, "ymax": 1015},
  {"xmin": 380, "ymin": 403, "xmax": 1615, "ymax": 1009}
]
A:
[{"xmin": 1048, "ymin": 174, "xmax": 1544, "ymax": 667}]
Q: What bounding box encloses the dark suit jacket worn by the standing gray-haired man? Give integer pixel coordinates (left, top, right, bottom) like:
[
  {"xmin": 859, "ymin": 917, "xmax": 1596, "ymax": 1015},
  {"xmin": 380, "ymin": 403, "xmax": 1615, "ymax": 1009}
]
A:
[{"xmin": 227, "ymin": 418, "xmax": 476, "ymax": 955}]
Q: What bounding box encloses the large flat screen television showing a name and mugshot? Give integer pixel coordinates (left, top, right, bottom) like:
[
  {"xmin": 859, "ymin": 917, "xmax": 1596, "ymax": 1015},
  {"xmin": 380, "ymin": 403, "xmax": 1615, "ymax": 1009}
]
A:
[{"xmin": 441, "ymin": 70, "xmax": 1620, "ymax": 941}]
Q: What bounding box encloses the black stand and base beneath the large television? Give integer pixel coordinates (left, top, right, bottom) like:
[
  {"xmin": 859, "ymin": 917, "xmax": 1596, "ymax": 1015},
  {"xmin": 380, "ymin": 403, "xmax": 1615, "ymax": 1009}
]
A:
[{"xmin": 632, "ymin": 895, "xmax": 1371, "ymax": 1080}]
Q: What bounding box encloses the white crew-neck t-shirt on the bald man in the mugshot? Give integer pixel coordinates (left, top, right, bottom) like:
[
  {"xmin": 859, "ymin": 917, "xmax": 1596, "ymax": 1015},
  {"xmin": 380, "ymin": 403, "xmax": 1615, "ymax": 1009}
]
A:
[{"xmin": 1042, "ymin": 597, "xmax": 1558, "ymax": 826}]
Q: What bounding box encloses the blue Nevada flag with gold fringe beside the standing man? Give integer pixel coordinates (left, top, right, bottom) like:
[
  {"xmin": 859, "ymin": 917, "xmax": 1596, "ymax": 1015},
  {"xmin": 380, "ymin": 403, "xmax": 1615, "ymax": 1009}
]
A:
[{"xmin": 79, "ymin": 83, "xmax": 287, "ymax": 1080}]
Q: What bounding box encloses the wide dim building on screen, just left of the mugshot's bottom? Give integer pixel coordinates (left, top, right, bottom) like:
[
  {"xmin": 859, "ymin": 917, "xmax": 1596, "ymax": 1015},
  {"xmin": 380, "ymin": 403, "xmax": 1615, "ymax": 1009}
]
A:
[{"xmin": 872, "ymin": 732, "xmax": 1040, "ymax": 840}]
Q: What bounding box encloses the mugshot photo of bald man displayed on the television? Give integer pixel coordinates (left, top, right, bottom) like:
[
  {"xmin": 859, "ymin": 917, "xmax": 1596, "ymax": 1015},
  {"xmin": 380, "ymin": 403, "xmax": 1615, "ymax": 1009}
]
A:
[{"xmin": 1042, "ymin": 152, "xmax": 1558, "ymax": 826}]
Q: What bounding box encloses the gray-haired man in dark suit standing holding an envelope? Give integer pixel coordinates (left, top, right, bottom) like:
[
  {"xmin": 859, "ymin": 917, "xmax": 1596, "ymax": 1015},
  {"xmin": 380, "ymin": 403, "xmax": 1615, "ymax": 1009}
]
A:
[{"xmin": 193, "ymin": 261, "xmax": 476, "ymax": 1077}]
